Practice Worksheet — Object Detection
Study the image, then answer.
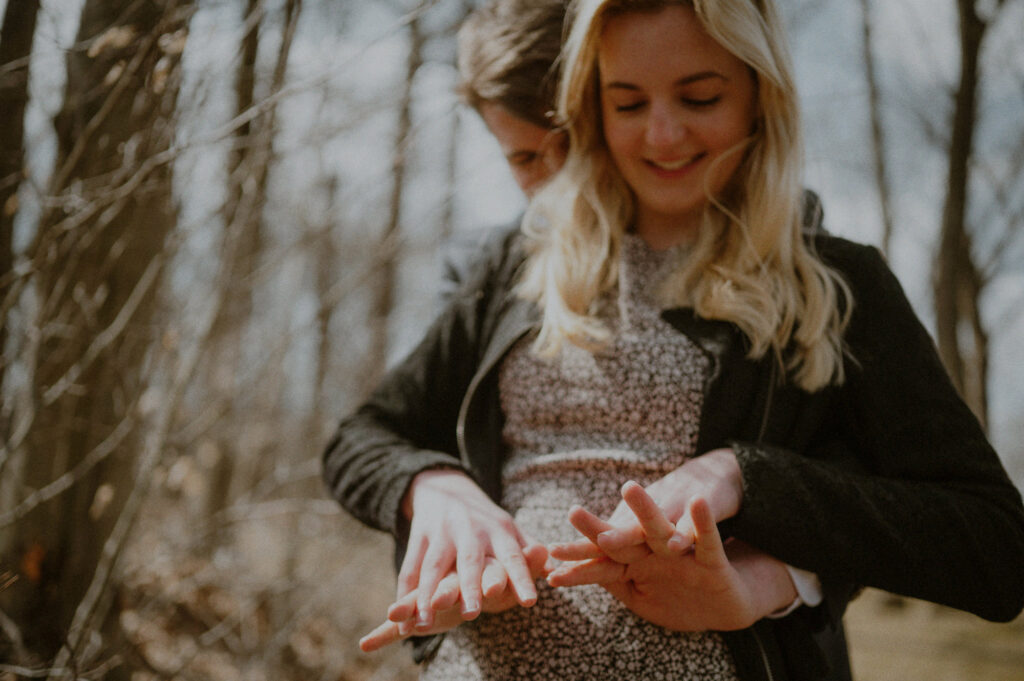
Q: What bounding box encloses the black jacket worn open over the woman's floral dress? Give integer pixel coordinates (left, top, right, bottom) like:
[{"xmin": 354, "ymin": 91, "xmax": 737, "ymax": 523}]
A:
[{"xmin": 324, "ymin": 216, "xmax": 1024, "ymax": 680}]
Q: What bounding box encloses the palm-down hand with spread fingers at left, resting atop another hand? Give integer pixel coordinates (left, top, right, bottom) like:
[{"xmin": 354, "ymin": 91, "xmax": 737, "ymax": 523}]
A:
[{"xmin": 389, "ymin": 469, "xmax": 547, "ymax": 636}]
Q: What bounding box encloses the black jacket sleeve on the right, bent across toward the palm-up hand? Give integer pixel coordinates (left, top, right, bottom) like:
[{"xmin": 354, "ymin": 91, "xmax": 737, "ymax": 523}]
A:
[{"xmin": 732, "ymin": 242, "xmax": 1024, "ymax": 622}]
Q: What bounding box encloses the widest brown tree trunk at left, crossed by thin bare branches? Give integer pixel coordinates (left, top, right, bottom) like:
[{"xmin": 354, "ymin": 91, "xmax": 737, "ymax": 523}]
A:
[{"xmin": 0, "ymin": 0, "xmax": 189, "ymax": 669}]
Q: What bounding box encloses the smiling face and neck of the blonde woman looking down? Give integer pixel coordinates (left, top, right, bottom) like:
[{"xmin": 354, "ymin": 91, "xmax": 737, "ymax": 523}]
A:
[{"xmin": 598, "ymin": 5, "xmax": 757, "ymax": 248}]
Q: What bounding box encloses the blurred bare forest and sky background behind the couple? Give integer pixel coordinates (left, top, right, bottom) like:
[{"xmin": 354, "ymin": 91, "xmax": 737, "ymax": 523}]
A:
[{"xmin": 0, "ymin": 0, "xmax": 1024, "ymax": 681}]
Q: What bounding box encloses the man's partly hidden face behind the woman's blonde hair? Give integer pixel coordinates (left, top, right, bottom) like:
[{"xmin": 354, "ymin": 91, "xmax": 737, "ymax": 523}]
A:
[{"xmin": 480, "ymin": 102, "xmax": 566, "ymax": 197}]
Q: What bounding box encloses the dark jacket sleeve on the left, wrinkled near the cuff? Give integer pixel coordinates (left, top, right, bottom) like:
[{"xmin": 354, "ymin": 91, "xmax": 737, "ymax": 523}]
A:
[{"xmin": 323, "ymin": 231, "xmax": 512, "ymax": 538}]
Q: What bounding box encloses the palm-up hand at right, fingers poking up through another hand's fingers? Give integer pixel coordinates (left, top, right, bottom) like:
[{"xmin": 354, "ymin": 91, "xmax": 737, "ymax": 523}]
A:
[{"xmin": 548, "ymin": 485, "xmax": 797, "ymax": 631}]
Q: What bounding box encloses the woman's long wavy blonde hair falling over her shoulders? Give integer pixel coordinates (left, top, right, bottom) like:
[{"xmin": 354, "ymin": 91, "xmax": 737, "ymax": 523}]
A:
[{"xmin": 517, "ymin": 0, "xmax": 853, "ymax": 391}]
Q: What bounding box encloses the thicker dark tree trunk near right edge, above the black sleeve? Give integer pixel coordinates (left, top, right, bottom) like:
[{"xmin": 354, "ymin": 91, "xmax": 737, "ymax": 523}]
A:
[{"xmin": 932, "ymin": 0, "xmax": 988, "ymax": 425}]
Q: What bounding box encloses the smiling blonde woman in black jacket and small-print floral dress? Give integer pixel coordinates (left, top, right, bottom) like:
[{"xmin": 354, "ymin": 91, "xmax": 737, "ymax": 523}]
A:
[{"xmin": 325, "ymin": 0, "xmax": 1024, "ymax": 681}]
